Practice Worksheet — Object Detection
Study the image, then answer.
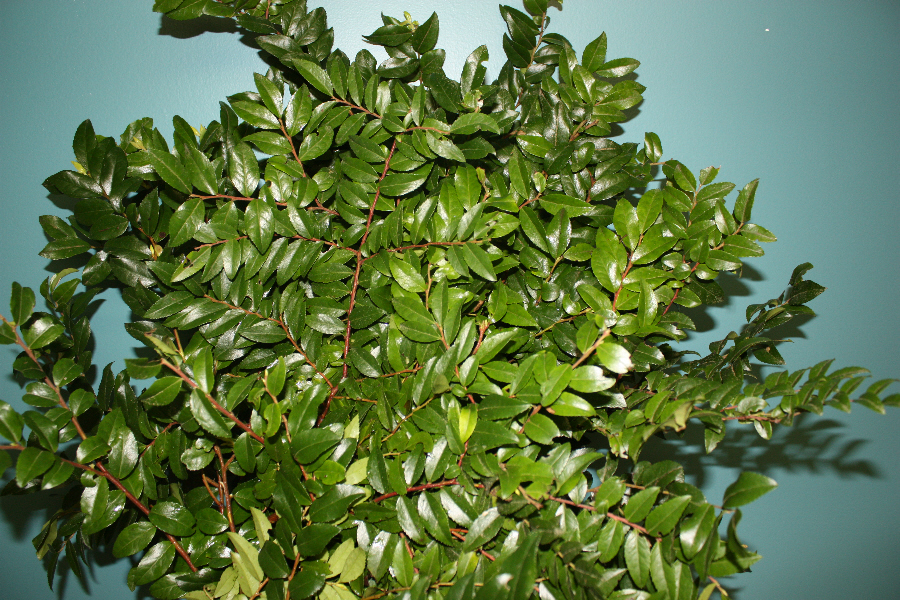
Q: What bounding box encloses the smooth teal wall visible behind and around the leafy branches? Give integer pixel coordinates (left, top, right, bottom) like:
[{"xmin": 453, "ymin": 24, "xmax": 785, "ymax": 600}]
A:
[{"xmin": 0, "ymin": 0, "xmax": 900, "ymax": 600}]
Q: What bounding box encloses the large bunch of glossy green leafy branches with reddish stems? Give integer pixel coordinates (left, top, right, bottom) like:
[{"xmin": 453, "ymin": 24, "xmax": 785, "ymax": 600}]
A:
[{"xmin": 0, "ymin": 0, "xmax": 900, "ymax": 600}]
